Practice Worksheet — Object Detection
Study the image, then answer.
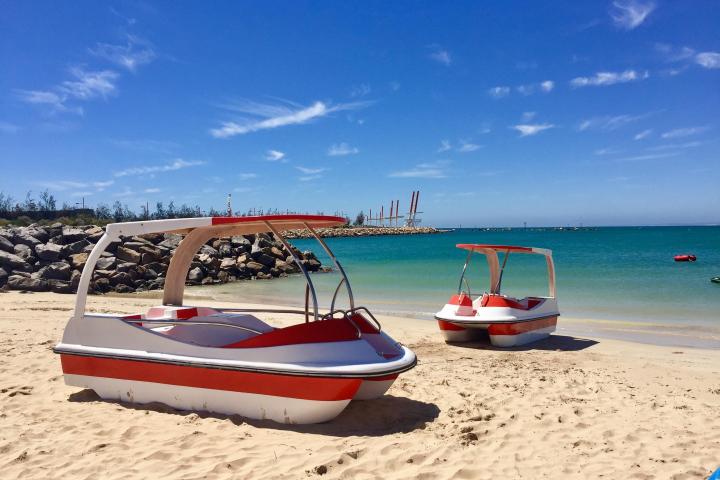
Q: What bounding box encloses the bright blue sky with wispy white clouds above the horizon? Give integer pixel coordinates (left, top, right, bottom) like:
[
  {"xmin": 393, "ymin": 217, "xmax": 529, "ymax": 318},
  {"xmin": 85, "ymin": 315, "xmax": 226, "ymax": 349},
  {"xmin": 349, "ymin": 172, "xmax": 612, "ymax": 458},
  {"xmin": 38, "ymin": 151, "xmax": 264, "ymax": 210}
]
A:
[{"xmin": 0, "ymin": 0, "xmax": 720, "ymax": 226}]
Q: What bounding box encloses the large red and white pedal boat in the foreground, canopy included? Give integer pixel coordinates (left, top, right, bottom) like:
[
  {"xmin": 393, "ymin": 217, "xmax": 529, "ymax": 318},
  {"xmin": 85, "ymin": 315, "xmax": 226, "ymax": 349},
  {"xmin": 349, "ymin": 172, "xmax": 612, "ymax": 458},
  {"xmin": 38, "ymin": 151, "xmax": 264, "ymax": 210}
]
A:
[{"xmin": 54, "ymin": 215, "xmax": 416, "ymax": 423}]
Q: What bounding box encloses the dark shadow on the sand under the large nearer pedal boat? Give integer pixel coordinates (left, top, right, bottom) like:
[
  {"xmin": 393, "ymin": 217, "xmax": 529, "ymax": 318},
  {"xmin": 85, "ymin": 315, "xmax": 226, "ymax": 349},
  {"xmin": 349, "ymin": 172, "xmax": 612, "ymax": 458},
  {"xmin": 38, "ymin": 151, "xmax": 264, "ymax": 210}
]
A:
[{"xmin": 68, "ymin": 389, "xmax": 440, "ymax": 437}]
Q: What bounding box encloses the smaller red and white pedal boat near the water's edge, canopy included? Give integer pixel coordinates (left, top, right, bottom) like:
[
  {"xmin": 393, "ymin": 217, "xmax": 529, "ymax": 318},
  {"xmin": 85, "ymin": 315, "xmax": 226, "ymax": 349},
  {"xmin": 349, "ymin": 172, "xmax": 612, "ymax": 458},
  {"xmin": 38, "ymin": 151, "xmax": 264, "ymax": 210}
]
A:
[{"xmin": 435, "ymin": 244, "xmax": 560, "ymax": 347}]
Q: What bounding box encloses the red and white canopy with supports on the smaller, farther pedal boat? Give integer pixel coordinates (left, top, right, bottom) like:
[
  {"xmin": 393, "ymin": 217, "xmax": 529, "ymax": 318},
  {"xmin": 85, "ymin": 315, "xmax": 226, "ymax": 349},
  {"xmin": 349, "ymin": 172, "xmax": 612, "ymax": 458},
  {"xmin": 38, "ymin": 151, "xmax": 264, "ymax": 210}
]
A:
[{"xmin": 456, "ymin": 243, "xmax": 556, "ymax": 298}]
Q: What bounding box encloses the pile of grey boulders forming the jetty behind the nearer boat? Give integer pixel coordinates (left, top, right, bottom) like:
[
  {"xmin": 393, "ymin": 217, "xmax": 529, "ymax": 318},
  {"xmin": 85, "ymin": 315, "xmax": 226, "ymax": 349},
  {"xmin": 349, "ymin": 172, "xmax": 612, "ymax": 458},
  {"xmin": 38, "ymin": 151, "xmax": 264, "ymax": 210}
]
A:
[{"xmin": 0, "ymin": 223, "xmax": 325, "ymax": 293}]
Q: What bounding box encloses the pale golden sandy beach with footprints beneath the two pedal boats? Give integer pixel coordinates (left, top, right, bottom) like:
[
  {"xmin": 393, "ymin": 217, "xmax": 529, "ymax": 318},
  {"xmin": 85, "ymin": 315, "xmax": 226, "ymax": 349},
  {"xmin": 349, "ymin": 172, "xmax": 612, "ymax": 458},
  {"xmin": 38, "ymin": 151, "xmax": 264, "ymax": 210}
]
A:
[{"xmin": 0, "ymin": 292, "xmax": 720, "ymax": 479}]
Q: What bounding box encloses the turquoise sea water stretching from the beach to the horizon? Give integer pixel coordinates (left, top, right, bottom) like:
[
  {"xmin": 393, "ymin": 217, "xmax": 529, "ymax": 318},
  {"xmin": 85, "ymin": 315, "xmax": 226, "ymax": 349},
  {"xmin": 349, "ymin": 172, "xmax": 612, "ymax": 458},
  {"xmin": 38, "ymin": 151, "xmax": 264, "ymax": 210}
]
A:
[{"xmin": 194, "ymin": 227, "xmax": 720, "ymax": 329}]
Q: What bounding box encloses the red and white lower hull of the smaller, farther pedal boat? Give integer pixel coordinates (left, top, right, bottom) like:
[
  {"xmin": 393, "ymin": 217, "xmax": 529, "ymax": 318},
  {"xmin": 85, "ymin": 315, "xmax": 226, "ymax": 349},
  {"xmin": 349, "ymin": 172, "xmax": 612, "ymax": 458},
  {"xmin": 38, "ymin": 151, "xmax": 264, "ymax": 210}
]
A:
[{"xmin": 436, "ymin": 315, "xmax": 558, "ymax": 347}]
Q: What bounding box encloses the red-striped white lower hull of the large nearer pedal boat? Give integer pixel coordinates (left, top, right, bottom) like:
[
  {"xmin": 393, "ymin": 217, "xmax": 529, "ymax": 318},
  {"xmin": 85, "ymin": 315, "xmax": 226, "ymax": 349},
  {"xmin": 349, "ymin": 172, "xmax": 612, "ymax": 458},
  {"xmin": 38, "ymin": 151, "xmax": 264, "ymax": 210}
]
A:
[{"xmin": 61, "ymin": 354, "xmax": 362, "ymax": 424}]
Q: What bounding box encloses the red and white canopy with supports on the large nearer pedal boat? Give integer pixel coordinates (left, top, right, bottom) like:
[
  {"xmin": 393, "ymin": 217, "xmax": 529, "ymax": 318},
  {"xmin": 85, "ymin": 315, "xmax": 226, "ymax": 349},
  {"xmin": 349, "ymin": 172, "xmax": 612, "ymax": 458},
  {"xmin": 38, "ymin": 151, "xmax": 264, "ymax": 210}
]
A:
[{"xmin": 75, "ymin": 214, "xmax": 354, "ymax": 319}]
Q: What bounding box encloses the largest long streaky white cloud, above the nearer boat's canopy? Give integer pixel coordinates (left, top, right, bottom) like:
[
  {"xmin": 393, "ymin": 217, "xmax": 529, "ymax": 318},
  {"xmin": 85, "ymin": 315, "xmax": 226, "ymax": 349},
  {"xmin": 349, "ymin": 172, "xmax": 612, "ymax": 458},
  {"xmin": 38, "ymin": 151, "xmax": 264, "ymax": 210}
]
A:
[{"xmin": 210, "ymin": 100, "xmax": 370, "ymax": 138}]
